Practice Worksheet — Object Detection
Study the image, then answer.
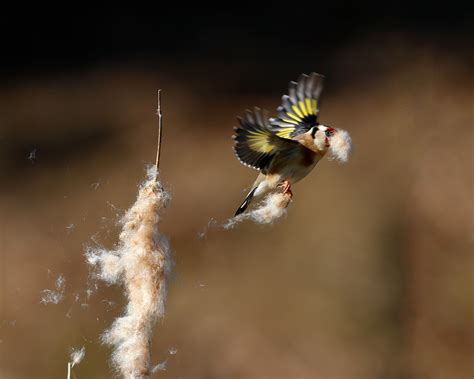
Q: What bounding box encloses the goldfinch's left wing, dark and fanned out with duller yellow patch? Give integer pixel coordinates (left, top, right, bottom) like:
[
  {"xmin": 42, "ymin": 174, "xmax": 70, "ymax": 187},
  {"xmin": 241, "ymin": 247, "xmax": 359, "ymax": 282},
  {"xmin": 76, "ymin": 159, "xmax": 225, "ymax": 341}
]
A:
[{"xmin": 234, "ymin": 108, "xmax": 300, "ymax": 172}]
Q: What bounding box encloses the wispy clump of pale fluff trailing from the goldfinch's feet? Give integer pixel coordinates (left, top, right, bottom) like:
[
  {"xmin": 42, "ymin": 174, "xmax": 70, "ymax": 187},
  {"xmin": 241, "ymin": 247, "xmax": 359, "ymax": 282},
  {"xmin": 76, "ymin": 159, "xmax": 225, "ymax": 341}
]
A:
[{"xmin": 224, "ymin": 192, "xmax": 291, "ymax": 229}]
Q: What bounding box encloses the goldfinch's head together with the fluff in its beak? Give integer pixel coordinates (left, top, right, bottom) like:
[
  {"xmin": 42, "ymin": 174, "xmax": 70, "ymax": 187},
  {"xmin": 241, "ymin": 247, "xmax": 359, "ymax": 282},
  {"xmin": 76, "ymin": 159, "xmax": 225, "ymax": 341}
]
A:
[{"xmin": 308, "ymin": 124, "xmax": 352, "ymax": 162}]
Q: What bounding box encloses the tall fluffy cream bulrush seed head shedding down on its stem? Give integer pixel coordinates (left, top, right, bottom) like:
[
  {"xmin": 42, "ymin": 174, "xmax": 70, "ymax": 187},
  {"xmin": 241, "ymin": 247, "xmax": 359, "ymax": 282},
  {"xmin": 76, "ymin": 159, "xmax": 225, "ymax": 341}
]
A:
[{"xmin": 86, "ymin": 166, "xmax": 173, "ymax": 378}]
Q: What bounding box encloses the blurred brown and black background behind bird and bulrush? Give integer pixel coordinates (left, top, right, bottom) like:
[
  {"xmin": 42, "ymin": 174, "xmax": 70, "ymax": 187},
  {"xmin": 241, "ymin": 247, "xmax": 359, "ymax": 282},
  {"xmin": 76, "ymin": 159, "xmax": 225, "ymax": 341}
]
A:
[{"xmin": 0, "ymin": 2, "xmax": 474, "ymax": 379}]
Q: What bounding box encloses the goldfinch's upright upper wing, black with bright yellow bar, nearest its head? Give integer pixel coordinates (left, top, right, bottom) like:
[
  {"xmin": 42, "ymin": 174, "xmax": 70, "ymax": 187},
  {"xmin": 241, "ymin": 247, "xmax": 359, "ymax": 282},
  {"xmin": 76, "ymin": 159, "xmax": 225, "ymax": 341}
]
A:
[{"xmin": 270, "ymin": 72, "xmax": 324, "ymax": 139}]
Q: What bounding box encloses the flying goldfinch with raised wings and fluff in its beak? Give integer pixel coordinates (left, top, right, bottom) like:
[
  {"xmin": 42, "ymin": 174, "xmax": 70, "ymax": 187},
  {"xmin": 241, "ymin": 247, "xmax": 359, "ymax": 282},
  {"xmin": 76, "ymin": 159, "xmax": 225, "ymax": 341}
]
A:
[{"xmin": 234, "ymin": 73, "xmax": 351, "ymax": 216}]
